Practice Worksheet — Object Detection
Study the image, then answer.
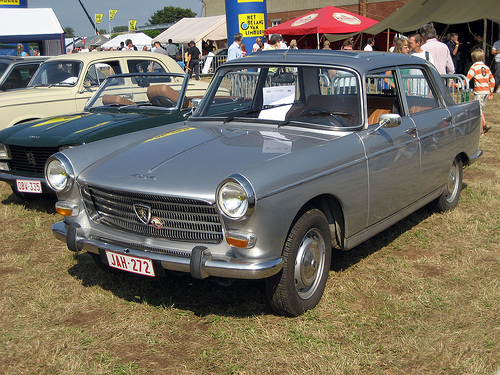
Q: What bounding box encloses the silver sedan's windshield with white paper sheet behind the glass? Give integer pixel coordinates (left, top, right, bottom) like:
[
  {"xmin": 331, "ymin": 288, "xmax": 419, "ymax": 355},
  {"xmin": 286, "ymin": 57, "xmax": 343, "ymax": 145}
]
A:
[{"xmin": 193, "ymin": 65, "xmax": 361, "ymax": 128}]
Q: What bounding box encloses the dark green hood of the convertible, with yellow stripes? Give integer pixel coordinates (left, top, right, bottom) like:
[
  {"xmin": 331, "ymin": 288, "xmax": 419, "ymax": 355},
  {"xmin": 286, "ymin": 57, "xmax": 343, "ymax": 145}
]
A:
[{"xmin": 0, "ymin": 110, "xmax": 176, "ymax": 147}]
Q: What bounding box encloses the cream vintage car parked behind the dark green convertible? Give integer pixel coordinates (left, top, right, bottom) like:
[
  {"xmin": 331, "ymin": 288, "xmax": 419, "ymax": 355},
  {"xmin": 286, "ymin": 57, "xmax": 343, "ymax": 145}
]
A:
[{"xmin": 0, "ymin": 51, "xmax": 188, "ymax": 129}]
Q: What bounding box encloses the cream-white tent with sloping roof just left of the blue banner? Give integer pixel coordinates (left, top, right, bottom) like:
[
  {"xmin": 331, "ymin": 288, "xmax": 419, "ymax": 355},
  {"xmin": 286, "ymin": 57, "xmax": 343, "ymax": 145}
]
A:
[{"xmin": 155, "ymin": 15, "xmax": 227, "ymax": 50}]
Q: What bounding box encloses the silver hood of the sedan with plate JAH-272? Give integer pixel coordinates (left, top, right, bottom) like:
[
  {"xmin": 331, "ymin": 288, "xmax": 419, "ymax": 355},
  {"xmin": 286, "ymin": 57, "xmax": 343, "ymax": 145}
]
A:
[{"xmin": 77, "ymin": 122, "xmax": 348, "ymax": 201}]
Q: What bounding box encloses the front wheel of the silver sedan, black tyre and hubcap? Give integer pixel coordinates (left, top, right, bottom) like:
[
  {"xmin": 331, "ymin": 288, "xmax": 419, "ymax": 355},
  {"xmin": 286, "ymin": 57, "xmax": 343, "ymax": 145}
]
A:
[{"xmin": 266, "ymin": 209, "xmax": 332, "ymax": 316}]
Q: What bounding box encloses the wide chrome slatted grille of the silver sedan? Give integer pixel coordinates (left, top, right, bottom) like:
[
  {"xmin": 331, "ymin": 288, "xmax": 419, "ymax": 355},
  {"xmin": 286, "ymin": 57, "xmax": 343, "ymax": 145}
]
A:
[{"xmin": 82, "ymin": 186, "xmax": 223, "ymax": 244}]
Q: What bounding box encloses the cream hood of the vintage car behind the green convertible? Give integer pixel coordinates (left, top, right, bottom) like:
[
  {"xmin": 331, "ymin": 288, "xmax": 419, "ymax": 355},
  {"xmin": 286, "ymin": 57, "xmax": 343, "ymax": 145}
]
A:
[{"xmin": 0, "ymin": 86, "xmax": 75, "ymax": 108}]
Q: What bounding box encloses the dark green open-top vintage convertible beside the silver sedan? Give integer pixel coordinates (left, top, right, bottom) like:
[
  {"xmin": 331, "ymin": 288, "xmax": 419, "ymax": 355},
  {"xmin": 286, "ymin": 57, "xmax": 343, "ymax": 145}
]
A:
[{"xmin": 0, "ymin": 73, "xmax": 208, "ymax": 199}]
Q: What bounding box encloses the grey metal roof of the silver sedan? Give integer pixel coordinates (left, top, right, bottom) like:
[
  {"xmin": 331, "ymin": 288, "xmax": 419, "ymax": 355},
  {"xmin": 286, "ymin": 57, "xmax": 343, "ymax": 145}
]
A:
[{"xmin": 224, "ymin": 49, "xmax": 425, "ymax": 71}]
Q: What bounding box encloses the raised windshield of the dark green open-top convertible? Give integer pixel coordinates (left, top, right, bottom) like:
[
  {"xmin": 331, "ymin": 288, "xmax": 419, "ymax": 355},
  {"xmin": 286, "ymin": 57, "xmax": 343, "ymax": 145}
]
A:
[{"xmin": 86, "ymin": 74, "xmax": 191, "ymax": 110}]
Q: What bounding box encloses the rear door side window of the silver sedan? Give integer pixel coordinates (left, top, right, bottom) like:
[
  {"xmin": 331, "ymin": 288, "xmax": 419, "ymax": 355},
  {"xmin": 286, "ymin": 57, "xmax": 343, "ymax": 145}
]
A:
[{"xmin": 401, "ymin": 68, "xmax": 439, "ymax": 114}]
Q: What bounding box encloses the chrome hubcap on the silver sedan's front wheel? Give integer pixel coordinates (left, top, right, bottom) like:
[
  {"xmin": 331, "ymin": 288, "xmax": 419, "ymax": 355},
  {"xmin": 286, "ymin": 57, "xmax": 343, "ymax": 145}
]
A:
[{"xmin": 294, "ymin": 229, "xmax": 326, "ymax": 299}]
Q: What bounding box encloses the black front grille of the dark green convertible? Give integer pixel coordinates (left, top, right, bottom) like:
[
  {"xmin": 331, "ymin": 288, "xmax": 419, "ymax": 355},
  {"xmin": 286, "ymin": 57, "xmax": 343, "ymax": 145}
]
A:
[{"xmin": 9, "ymin": 146, "xmax": 59, "ymax": 175}]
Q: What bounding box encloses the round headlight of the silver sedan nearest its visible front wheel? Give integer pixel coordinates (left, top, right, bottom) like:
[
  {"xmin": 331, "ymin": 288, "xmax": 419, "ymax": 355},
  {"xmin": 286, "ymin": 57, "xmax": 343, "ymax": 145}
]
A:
[{"xmin": 216, "ymin": 174, "xmax": 257, "ymax": 220}]
